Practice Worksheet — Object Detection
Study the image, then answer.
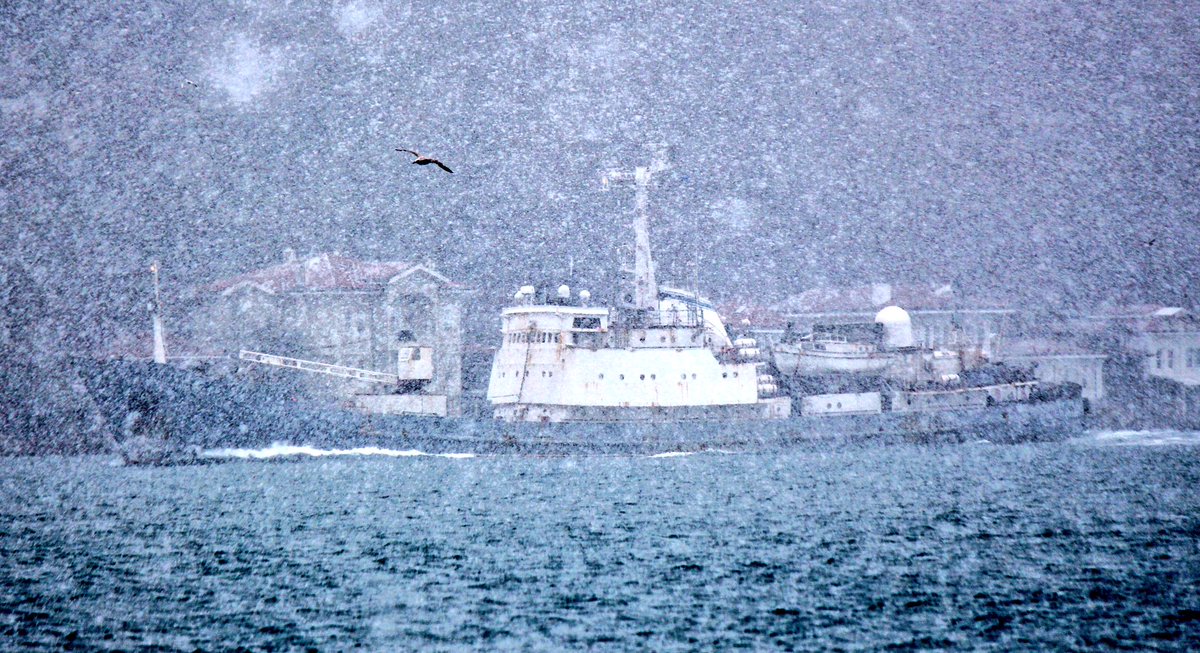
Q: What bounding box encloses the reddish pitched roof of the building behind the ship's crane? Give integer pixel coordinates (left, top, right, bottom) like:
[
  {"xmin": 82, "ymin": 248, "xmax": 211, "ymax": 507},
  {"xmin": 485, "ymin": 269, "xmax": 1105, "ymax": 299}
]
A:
[{"xmin": 204, "ymin": 253, "xmax": 452, "ymax": 294}]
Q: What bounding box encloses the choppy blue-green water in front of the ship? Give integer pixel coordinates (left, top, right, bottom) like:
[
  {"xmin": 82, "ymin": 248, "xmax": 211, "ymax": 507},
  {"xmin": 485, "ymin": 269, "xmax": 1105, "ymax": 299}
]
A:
[{"xmin": 0, "ymin": 432, "xmax": 1200, "ymax": 651}]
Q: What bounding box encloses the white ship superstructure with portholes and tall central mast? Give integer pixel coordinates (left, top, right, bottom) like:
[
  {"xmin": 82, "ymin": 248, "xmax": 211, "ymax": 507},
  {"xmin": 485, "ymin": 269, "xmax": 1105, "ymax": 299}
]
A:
[{"xmin": 487, "ymin": 153, "xmax": 791, "ymax": 423}]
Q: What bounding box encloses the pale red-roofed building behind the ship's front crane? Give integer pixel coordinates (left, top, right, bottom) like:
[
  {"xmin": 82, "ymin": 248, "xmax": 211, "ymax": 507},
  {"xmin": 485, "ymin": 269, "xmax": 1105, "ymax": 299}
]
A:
[{"xmin": 188, "ymin": 250, "xmax": 463, "ymax": 408}]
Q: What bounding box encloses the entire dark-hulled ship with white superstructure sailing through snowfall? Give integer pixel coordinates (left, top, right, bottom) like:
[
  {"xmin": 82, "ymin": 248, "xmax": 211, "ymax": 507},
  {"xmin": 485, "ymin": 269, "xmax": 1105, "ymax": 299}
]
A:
[{"xmin": 78, "ymin": 154, "xmax": 1082, "ymax": 465}]
